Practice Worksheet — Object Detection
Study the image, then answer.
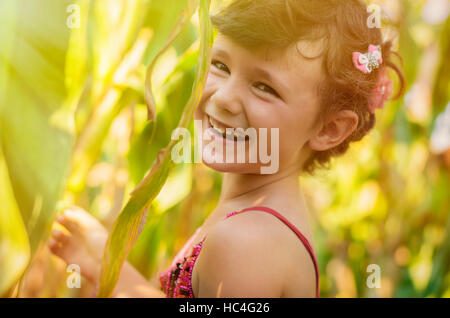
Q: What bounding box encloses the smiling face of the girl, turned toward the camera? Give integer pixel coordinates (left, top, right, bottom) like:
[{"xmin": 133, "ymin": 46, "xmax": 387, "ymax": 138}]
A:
[{"xmin": 194, "ymin": 34, "xmax": 323, "ymax": 174}]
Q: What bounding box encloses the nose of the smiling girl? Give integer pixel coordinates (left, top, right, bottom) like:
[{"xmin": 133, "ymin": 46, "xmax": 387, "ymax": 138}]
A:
[{"xmin": 211, "ymin": 80, "xmax": 243, "ymax": 115}]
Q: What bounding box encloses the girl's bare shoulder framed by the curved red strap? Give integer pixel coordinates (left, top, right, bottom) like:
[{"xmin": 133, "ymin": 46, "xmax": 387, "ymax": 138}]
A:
[{"xmin": 196, "ymin": 211, "xmax": 314, "ymax": 297}]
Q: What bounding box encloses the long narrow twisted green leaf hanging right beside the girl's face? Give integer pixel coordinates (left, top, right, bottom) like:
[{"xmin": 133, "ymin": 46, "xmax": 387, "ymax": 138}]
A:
[{"xmin": 97, "ymin": 0, "xmax": 213, "ymax": 297}]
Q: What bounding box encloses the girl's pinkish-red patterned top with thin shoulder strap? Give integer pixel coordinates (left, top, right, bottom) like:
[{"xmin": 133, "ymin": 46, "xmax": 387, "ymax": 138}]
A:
[{"xmin": 159, "ymin": 206, "xmax": 320, "ymax": 298}]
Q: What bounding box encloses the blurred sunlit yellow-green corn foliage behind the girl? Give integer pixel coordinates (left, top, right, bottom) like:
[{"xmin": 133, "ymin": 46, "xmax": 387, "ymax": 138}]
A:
[{"xmin": 0, "ymin": 0, "xmax": 450, "ymax": 297}]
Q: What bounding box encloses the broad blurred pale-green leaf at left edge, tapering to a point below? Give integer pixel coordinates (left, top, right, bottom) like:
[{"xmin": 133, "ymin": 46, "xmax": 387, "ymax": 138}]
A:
[{"xmin": 0, "ymin": 0, "xmax": 73, "ymax": 255}]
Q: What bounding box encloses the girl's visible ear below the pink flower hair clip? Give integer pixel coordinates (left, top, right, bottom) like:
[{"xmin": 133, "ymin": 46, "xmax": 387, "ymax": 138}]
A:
[{"xmin": 308, "ymin": 110, "xmax": 358, "ymax": 151}]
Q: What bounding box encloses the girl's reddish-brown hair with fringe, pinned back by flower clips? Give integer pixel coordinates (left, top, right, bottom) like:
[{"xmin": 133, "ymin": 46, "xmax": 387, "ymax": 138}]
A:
[{"xmin": 211, "ymin": 0, "xmax": 405, "ymax": 174}]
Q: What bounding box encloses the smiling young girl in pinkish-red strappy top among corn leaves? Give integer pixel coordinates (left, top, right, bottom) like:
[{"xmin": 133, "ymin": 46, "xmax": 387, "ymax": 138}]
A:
[{"xmin": 49, "ymin": 0, "xmax": 403, "ymax": 297}]
